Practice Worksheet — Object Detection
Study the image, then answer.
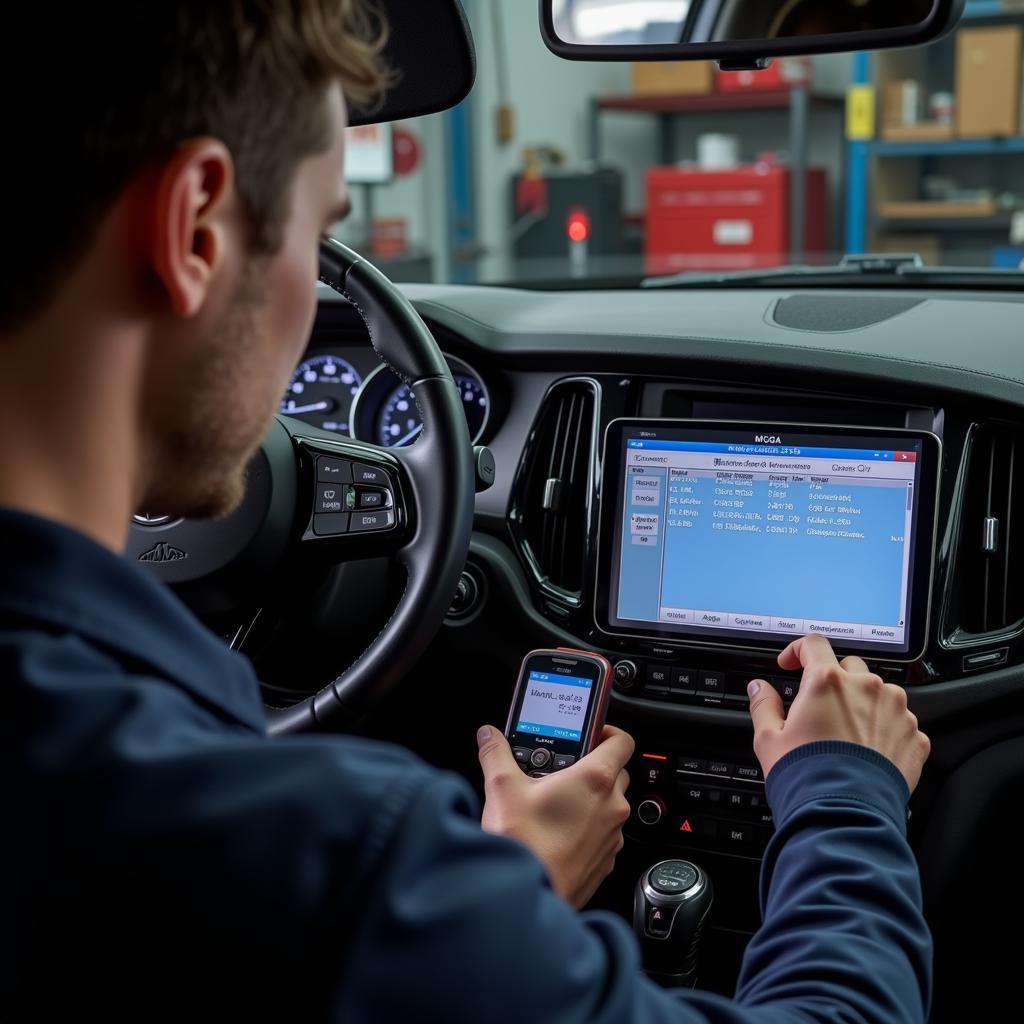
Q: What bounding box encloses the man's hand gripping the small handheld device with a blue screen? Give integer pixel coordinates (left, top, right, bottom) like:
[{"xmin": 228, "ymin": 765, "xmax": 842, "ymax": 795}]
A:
[{"xmin": 476, "ymin": 725, "xmax": 635, "ymax": 907}]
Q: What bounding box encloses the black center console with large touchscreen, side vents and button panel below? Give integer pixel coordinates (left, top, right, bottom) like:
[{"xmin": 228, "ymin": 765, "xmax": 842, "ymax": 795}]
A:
[{"xmin": 501, "ymin": 378, "xmax": 1007, "ymax": 991}]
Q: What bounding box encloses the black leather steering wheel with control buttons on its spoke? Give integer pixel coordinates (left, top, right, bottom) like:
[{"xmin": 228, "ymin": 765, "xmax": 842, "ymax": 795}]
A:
[{"xmin": 127, "ymin": 240, "xmax": 475, "ymax": 734}]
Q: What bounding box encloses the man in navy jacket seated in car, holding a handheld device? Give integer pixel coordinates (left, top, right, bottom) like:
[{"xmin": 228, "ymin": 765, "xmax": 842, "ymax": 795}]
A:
[{"xmin": 0, "ymin": 0, "xmax": 931, "ymax": 1024}]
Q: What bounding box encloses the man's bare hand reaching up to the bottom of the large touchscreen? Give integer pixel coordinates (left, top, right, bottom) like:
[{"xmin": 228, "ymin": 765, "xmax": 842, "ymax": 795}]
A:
[{"xmin": 748, "ymin": 636, "xmax": 932, "ymax": 793}]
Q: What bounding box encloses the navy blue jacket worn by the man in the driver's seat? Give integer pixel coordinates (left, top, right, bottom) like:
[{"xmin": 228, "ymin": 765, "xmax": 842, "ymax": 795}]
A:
[{"xmin": 0, "ymin": 512, "xmax": 931, "ymax": 1024}]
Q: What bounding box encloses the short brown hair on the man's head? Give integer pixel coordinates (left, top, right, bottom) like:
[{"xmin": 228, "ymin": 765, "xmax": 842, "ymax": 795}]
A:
[{"xmin": 0, "ymin": 0, "xmax": 387, "ymax": 331}]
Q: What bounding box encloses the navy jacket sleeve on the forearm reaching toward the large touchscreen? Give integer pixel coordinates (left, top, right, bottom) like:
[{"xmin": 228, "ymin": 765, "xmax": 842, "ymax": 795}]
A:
[{"xmin": 736, "ymin": 742, "xmax": 932, "ymax": 1022}]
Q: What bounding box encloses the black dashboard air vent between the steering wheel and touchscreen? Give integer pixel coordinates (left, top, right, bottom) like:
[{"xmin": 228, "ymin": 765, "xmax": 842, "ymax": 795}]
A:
[{"xmin": 512, "ymin": 380, "xmax": 597, "ymax": 605}]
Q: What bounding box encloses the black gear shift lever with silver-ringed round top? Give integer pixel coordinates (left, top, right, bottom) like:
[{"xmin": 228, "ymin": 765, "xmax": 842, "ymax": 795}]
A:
[{"xmin": 633, "ymin": 860, "xmax": 713, "ymax": 988}]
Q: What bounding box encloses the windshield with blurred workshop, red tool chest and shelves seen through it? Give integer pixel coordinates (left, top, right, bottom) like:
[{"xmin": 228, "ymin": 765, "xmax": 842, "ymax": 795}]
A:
[{"xmin": 337, "ymin": 0, "xmax": 1024, "ymax": 288}]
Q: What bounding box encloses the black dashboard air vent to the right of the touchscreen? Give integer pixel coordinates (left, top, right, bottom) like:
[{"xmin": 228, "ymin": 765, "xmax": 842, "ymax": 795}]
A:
[{"xmin": 956, "ymin": 423, "xmax": 1024, "ymax": 635}]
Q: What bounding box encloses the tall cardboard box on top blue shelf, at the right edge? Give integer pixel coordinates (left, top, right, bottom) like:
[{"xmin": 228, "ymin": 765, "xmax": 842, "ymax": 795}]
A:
[{"xmin": 956, "ymin": 25, "xmax": 1024, "ymax": 138}]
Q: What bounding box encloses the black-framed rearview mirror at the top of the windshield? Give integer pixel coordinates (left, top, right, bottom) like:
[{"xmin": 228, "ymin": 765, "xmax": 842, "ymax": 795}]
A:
[{"xmin": 541, "ymin": 0, "xmax": 965, "ymax": 68}]
